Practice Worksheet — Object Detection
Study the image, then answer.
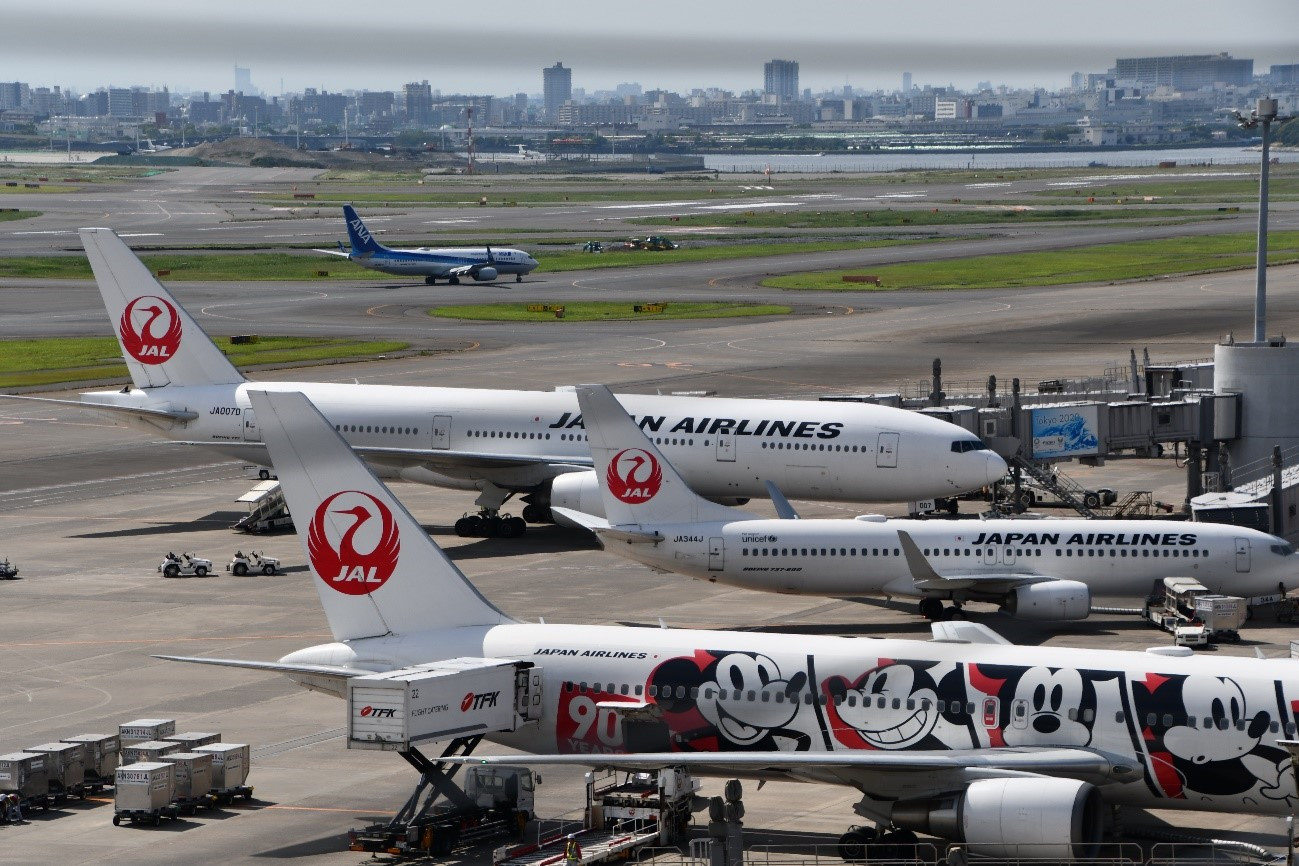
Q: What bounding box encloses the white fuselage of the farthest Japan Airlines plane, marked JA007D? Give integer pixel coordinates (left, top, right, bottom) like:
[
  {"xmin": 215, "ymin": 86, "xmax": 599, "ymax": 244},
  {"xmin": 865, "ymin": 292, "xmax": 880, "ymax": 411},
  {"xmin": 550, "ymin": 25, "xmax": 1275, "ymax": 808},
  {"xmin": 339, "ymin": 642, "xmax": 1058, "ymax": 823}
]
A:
[{"xmin": 83, "ymin": 382, "xmax": 1004, "ymax": 503}]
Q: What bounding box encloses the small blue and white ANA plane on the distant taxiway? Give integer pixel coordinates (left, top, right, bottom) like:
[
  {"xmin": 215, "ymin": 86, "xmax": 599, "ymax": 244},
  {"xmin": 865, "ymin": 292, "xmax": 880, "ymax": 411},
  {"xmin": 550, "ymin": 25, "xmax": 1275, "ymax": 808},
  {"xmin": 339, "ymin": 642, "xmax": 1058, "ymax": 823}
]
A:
[{"xmin": 316, "ymin": 204, "xmax": 538, "ymax": 286}]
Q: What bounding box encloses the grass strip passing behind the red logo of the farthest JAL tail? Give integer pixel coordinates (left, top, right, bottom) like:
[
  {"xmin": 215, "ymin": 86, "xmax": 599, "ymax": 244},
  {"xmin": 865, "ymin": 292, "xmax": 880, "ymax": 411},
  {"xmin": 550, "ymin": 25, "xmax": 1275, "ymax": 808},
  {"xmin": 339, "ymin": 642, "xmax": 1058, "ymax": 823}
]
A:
[{"xmin": 0, "ymin": 336, "xmax": 408, "ymax": 388}]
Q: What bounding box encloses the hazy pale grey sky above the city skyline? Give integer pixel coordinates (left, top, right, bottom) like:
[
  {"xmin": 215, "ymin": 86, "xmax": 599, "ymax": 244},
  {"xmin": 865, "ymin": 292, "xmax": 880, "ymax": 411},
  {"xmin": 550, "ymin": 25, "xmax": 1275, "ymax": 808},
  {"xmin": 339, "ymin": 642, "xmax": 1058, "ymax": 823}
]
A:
[{"xmin": 0, "ymin": 0, "xmax": 1299, "ymax": 97}]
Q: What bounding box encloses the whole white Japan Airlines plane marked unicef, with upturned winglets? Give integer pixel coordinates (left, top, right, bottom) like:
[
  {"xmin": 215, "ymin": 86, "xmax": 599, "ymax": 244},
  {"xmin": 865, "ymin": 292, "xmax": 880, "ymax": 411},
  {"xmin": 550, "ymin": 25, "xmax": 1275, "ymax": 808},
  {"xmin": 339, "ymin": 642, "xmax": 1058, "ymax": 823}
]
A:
[{"xmin": 557, "ymin": 386, "xmax": 1299, "ymax": 621}]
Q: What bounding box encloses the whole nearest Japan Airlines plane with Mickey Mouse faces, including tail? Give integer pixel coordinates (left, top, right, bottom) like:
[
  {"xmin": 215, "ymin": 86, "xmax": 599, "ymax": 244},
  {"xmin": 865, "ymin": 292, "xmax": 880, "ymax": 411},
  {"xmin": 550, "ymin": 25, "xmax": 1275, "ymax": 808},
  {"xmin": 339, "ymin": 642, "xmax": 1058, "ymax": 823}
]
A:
[{"xmin": 164, "ymin": 391, "xmax": 1299, "ymax": 862}]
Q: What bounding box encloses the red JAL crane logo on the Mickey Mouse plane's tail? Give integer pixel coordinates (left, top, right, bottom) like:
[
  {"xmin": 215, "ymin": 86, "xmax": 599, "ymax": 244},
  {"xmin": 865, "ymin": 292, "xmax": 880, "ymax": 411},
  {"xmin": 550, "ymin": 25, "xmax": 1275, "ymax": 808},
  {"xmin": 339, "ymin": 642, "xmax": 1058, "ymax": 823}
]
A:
[{"xmin": 307, "ymin": 491, "xmax": 401, "ymax": 596}]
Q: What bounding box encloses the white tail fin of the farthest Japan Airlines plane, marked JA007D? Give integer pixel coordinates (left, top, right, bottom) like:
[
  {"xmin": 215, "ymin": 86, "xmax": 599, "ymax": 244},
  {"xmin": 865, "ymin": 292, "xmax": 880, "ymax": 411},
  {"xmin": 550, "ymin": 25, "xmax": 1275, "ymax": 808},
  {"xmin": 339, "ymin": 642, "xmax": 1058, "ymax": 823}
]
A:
[{"xmin": 81, "ymin": 229, "xmax": 244, "ymax": 388}]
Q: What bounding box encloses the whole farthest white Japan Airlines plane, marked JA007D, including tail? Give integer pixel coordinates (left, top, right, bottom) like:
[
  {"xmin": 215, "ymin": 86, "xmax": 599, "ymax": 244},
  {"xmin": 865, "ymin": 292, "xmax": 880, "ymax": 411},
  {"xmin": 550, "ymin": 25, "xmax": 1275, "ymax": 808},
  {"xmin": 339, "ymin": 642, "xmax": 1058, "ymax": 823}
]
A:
[{"xmin": 2, "ymin": 229, "xmax": 1005, "ymax": 535}]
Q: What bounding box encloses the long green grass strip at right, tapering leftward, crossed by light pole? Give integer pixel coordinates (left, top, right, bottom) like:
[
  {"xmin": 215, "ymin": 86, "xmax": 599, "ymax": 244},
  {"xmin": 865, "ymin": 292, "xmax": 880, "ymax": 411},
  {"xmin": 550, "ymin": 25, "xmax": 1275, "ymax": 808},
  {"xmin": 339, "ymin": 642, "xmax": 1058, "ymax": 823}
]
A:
[{"xmin": 763, "ymin": 231, "xmax": 1299, "ymax": 291}]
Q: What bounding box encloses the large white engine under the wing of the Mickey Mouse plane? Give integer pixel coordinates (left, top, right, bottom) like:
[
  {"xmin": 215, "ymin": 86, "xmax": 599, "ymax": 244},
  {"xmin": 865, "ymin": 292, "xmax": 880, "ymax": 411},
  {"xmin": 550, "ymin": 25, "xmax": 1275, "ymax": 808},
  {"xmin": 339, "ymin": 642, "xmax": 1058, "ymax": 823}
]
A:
[{"xmin": 892, "ymin": 778, "xmax": 1104, "ymax": 863}]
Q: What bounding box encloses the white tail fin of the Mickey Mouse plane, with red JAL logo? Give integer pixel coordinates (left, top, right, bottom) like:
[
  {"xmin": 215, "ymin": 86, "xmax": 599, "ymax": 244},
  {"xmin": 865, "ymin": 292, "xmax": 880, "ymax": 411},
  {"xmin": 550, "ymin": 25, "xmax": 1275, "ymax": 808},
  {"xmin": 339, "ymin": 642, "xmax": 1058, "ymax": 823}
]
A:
[{"xmin": 248, "ymin": 391, "xmax": 513, "ymax": 640}]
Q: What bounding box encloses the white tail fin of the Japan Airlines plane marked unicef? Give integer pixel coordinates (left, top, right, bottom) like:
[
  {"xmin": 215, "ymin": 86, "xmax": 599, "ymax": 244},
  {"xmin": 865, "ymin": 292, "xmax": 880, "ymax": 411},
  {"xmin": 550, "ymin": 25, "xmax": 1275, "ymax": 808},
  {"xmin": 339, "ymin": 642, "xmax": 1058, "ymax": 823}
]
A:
[{"xmin": 577, "ymin": 384, "xmax": 753, "ymax": 526}]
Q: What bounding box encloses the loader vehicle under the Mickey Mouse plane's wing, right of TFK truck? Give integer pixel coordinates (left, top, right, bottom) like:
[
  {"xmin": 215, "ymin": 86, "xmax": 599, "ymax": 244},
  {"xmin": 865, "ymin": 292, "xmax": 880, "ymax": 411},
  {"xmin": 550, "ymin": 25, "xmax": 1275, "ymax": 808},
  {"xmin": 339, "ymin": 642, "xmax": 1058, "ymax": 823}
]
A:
[{"xmin": 492, "ymin": 767, "xmax": 699, "ymax": 866}]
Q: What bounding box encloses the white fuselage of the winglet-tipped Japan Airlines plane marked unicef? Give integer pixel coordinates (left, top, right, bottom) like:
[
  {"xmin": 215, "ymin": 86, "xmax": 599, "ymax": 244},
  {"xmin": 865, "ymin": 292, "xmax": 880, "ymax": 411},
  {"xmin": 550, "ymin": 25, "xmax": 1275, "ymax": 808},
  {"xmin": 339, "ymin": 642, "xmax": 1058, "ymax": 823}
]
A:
[{"xmin": 607, "ymin": 518, "xmax": 1299, "ymax": 597}]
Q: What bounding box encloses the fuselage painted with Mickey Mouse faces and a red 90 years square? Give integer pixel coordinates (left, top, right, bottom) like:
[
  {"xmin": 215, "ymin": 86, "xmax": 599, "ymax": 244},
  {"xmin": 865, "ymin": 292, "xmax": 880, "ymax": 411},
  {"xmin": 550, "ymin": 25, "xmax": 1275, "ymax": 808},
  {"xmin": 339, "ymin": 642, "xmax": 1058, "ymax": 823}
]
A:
[{"xmin": 281, "ymin": 625, "xmax": 1299, "ymax": 814}]
